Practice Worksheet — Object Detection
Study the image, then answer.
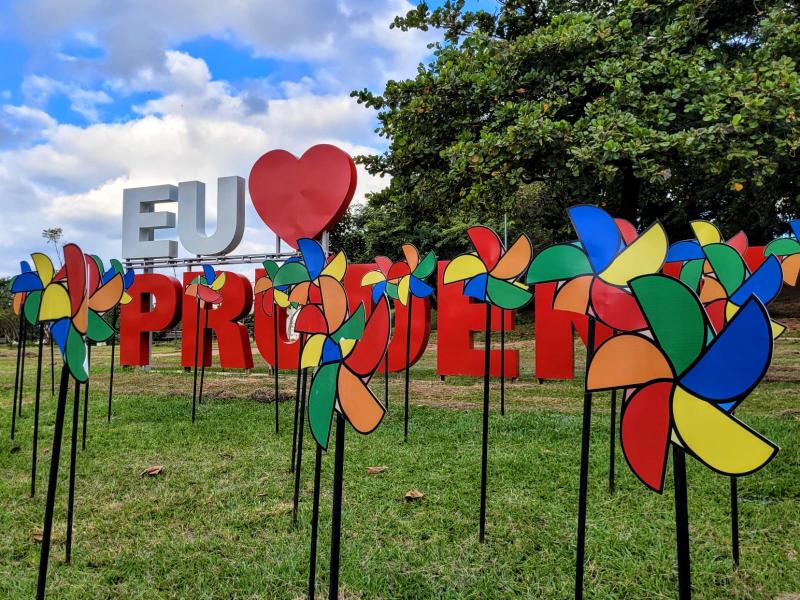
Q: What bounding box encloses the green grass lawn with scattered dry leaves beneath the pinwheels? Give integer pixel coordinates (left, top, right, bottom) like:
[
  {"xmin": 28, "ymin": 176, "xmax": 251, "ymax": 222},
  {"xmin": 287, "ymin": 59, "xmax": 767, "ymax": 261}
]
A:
[{"xmin": 0, "ymin": 338, "xmax": 800, "ymax": 599}]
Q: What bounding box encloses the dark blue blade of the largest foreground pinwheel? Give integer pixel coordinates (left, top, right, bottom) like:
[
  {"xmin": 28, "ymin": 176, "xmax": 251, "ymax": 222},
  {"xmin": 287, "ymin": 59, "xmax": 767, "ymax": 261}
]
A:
[{"xmin": 680, "ymin": 296, "xmax": 772, "ymax": 403}]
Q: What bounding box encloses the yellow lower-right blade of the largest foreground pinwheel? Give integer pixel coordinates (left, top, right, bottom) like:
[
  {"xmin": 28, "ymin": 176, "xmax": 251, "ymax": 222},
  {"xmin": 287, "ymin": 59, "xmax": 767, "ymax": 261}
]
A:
[{"xmin": 672, "ymin": 386, "xmax": 778, "ymax": 475}]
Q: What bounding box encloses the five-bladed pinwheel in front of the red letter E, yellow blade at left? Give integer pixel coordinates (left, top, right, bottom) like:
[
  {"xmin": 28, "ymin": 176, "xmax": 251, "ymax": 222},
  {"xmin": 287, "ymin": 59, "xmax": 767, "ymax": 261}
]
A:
[{"xmin": 443, "ymin": 225, "xmax": 533, "ymax": 310}]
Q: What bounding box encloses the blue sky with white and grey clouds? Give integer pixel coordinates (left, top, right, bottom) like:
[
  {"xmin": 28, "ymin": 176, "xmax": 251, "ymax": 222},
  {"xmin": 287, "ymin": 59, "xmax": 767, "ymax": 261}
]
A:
[{"xmin": 0, "ymin": 0, "xmax": 495, "ymax": 273}]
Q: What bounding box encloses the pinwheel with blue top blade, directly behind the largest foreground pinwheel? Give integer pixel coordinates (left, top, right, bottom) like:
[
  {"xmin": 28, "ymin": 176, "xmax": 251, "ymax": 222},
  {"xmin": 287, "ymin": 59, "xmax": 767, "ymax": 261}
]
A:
[{"xmin": 526, "ymin": 205, "xmax": 669, "ymax": 331}]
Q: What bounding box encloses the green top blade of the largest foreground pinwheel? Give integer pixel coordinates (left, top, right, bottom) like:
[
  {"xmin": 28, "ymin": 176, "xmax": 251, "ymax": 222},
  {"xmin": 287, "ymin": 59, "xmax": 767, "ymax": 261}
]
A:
[{"xmin": 629, "ymin": 274, "xmax": 707, "ymax": 376}]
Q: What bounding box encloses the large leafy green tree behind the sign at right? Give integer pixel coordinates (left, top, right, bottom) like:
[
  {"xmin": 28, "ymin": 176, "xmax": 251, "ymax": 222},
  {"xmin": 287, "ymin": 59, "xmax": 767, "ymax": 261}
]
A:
[{"xmin": 354, "ymin": 0, "xmax": 800, "ymax": 256}]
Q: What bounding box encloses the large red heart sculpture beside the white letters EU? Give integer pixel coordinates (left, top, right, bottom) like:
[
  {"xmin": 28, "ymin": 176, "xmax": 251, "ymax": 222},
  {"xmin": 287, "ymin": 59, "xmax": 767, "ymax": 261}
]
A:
[{"xmin": 249, "ymin": 144, "xmax": 357, "ymax": 249}]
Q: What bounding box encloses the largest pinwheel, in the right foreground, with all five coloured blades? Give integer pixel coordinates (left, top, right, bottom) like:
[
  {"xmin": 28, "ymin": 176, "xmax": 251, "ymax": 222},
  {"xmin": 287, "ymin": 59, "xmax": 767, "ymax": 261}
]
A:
[{"xmin": 586, "ymin": 275, "xmax": 778, "ymax": 492}]
